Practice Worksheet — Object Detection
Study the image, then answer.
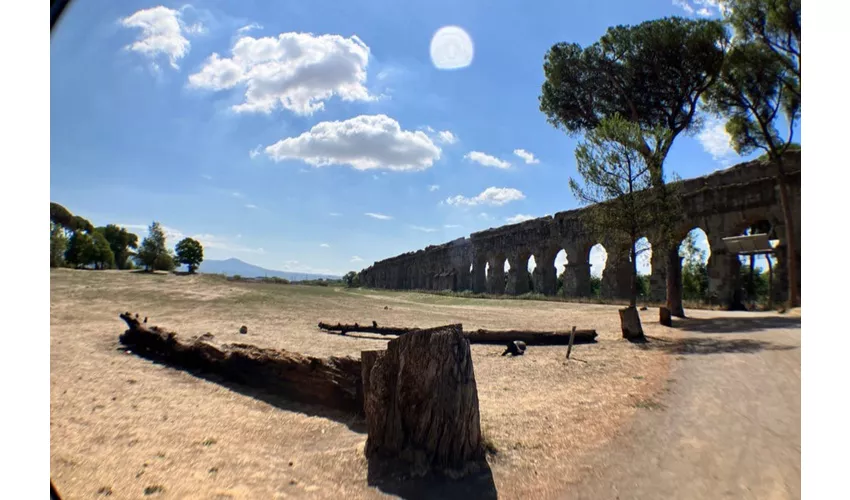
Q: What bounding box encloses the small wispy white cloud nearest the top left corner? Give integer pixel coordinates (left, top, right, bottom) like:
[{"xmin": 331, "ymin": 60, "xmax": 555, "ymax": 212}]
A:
[{"xmin": 119, "ymin": 6, "xmax": 199, "ymax": 69}]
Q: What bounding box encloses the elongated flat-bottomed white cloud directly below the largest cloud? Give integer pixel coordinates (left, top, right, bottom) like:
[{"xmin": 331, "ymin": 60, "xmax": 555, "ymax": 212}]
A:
[{"xmin": 265, "ymin": 115, "xmax": 441, "ymax": 171}]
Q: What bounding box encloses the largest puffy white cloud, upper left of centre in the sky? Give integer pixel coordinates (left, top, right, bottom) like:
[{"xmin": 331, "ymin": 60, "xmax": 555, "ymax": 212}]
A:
[{"xmin": 189, "ymin": 33, "xmax": 373, "ymax": 115}]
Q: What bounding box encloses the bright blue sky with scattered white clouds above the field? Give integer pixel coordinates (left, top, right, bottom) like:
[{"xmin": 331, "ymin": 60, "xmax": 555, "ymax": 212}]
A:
[{"xmin": 50, "ymin": 0, "xmax": 784, "ymax": 274}]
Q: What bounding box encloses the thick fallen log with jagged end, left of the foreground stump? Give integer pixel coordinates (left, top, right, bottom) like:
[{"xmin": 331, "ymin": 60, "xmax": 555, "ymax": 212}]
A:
[{"xmin": 119, "ymin": 313, "xmax": 363, "ymax": 414}]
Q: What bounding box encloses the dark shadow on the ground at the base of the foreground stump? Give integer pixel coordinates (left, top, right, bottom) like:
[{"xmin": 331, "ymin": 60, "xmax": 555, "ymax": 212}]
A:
[{"xmin": 368, "ymin": 458, "xmax": 499, "ymax": 500}]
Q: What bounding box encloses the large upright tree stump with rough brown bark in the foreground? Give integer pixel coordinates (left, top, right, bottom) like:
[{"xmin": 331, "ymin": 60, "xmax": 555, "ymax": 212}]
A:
[{"xmin": 361, "ymin": 325, "xmax": 484, "ymax": 477}]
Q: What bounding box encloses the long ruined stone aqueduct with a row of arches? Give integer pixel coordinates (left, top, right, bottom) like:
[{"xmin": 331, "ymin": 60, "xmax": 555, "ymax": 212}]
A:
[{"xmin": 360, "ymin": 151, "xmax": 801, "ymax": 304}]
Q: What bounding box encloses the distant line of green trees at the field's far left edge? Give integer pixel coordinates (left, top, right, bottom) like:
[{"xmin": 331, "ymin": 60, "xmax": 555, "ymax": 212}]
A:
[{"xmin": 50, "ymin": 202, "xmax": 204, "ymax": 274}]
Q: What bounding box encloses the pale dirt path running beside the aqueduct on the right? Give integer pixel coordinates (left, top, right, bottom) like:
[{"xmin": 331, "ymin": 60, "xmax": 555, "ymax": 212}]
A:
[{"xmin": 565, "ymin": 313, "xmax": 800, "ymax": 500}]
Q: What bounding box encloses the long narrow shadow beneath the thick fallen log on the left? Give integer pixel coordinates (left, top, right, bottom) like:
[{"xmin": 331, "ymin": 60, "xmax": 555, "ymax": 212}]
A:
[{"xmin": 117, "ymin": 346, "xmax": 368, "ymax": 434}]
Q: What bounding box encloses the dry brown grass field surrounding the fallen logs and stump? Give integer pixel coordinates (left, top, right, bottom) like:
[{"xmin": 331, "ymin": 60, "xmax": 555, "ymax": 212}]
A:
[{"xmin": 50, "ymin": 270, "xmax": 668, "ymax": 499}]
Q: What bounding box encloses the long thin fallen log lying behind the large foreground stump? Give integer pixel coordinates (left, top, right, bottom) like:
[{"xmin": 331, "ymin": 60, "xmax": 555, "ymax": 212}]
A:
[{"xmin": 319, "ymin": 322, "xmax": 597, "ymax": 345}]
